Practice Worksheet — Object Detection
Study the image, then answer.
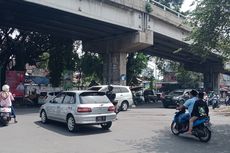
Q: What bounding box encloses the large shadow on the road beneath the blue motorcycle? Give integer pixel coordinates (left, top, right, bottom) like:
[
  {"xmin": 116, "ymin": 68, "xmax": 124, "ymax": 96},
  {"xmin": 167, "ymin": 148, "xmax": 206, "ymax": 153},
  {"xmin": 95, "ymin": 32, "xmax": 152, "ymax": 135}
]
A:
[{"xmin": 129, "ymin": 125, "xmax": 230, "ymax": 153}]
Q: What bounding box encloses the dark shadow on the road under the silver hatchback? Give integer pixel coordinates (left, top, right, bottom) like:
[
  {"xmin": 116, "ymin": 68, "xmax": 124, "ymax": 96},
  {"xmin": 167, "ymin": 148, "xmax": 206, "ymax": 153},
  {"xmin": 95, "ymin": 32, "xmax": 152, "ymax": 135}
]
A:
[{"xmin": 34, "ymin": 121, "xmax": 111, "ymax": 136}]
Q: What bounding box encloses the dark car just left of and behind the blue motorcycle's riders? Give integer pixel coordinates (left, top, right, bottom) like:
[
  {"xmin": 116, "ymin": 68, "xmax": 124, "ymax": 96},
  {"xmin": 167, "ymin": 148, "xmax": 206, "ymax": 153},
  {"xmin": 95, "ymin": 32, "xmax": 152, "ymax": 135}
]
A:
[{"xmin": 162, "ymin": 89, "xmax": 192, "ymax": 108}]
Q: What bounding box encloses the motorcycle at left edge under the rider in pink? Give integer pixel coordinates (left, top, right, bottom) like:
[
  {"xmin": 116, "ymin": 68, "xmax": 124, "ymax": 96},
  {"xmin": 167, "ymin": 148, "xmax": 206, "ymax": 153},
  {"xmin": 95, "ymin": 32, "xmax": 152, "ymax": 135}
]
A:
[{"xmin": 0, "ymin": 107, "xmax": 11, "ymax": 126}]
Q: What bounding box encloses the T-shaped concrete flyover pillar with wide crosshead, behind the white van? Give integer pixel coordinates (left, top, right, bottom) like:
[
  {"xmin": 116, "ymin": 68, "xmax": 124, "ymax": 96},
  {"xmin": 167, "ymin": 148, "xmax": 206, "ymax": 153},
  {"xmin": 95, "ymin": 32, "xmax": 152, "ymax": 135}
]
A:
[{"xmin": 83, "ymin": 31, "xmax": 153, "ymax": 85}]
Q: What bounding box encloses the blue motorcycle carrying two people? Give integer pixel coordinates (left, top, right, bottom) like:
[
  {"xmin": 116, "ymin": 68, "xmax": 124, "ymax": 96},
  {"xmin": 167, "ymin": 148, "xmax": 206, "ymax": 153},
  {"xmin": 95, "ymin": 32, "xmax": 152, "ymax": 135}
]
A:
[{"xmin": 171, "ymin": 111, "xmax": 211, "ymax": 142}]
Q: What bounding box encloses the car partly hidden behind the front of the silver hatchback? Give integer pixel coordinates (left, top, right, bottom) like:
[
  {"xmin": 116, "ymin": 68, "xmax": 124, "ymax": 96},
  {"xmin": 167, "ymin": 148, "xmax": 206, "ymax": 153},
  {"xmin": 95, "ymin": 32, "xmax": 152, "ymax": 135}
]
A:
[{"xmin": 38, "ymin": 91, "xmax": 60, "ymax": 104}]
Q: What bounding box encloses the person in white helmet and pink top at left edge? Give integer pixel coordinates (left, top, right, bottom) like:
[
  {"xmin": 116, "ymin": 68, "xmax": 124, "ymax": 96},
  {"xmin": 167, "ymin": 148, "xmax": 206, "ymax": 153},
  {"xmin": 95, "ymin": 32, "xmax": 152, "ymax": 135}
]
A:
[{"xmin": 0, "ymin": 84, "xmax": 18, "ymax": 123}]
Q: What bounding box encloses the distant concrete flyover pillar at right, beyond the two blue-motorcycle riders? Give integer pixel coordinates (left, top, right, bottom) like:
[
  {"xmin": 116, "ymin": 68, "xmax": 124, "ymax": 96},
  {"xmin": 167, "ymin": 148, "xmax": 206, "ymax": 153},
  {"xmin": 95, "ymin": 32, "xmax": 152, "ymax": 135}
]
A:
[{"xmin": 204, "ymin": 72, "xmax": 220, "ymax": 93}]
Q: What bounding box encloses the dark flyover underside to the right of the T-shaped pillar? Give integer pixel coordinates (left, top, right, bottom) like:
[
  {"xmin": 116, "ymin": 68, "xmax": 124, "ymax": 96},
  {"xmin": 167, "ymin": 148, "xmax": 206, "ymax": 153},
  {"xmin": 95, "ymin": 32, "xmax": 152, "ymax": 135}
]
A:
[{"xmin": 144, "ymin": 33, "xmax": 223, "ymax": 73}]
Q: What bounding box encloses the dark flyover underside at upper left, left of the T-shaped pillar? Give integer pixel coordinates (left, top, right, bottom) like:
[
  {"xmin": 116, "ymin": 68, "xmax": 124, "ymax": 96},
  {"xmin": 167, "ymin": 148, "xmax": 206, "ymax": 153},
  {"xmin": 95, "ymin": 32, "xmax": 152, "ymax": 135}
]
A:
[{"xmin": 0, "ymin": 0, "xmax": 135, "ymax": 41}]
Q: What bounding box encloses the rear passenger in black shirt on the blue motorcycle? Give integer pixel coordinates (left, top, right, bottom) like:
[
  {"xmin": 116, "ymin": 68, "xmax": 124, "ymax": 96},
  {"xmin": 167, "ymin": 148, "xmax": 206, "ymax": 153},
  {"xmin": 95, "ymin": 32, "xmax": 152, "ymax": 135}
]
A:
[{"xmin": 188, "ymin": 92, "xmax": 209, "ymax": 134}]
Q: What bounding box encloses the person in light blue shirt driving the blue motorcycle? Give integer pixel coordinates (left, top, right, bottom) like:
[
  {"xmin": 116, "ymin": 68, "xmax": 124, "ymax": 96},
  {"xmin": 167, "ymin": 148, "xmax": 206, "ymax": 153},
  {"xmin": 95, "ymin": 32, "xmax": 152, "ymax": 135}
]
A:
[{"xmin": 177, "ymin": 90, "xmax": 198, "ymax": 131}]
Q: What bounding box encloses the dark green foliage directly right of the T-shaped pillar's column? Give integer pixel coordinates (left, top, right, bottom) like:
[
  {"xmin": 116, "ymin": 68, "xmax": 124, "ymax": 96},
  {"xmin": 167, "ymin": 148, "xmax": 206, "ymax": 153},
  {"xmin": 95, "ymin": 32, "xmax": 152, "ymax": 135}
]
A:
[{"xmin": 127, "ymin": 53, "xmax": 148, "ymax": 85}]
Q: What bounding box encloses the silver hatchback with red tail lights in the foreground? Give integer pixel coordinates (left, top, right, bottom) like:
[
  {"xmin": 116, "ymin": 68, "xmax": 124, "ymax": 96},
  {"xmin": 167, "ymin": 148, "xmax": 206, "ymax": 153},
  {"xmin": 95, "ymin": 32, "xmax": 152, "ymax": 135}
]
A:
[{"xmin": 40, "ymin": 90, "xmax": 116, "ymax": 132}]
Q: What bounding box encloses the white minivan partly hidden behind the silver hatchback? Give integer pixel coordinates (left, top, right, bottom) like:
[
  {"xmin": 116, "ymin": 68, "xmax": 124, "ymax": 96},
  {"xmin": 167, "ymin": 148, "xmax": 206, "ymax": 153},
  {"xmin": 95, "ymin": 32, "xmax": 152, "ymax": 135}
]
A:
[{"xmin": 88, "ymin": 85, "xmax": 133, "ymax": 111}]
